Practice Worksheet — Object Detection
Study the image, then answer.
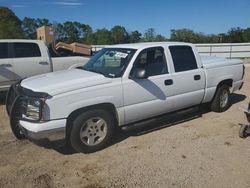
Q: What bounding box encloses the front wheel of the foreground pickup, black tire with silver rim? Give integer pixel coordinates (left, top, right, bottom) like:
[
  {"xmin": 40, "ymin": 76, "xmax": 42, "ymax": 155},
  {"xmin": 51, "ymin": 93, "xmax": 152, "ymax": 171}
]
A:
[{"xmin": 69, "ymin": 109, "xmax": 115, "ymax": 153}]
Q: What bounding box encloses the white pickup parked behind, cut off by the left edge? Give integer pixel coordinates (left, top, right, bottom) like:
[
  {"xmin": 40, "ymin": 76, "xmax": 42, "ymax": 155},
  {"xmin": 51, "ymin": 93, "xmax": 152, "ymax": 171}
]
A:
[{"xmin": 0, "ymin": 39, "xmax": 89, "ymax": 91}]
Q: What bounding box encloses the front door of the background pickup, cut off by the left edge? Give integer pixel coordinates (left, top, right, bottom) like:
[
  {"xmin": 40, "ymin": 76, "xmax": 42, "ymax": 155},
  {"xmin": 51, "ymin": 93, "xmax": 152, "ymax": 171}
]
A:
[{"xmin": 0, "ymin": 42, "xmax": 15, "ymax": 90}]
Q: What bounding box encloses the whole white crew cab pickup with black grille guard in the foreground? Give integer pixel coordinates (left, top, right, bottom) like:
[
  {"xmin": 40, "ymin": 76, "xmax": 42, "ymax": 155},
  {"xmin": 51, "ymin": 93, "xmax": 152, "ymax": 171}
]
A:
[{"xmin": 6, "ymin": 42, "xmax": 244, "ymax": 153}]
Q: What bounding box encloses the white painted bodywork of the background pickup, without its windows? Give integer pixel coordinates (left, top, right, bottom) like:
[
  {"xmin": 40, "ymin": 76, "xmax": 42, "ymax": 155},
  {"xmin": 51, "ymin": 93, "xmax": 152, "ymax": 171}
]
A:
[{"xmin": 0, "ymin": 39, "xmax": 89, "ymax": 91}]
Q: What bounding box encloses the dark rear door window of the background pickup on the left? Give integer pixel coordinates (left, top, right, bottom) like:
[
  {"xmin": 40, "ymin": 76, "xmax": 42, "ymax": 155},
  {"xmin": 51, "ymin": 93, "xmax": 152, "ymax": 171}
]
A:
[{"xmin": 13, "ymin": 42, "xmax": 41, "ymax": 58}]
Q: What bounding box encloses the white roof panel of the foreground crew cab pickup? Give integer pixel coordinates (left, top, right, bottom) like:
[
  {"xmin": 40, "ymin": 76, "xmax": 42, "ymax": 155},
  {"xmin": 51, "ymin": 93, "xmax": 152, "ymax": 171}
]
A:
[{"xmin": 107, "ymin": 42, "xmax": 193, "ymax": 49}]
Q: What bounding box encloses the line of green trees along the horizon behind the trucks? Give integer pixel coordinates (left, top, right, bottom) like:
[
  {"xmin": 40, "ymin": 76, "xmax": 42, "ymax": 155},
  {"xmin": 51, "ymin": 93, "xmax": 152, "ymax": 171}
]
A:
[{"xmin": 0, "ymin": 7, "xmax": 250, "ymax": 45}]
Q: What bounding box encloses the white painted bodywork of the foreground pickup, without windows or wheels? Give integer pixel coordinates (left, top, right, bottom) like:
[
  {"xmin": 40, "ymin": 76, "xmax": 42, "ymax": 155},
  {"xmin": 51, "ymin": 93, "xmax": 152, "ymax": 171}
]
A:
[{"xmin": 18, "ymin": 43, "xmax": 243, "ymax": 137}]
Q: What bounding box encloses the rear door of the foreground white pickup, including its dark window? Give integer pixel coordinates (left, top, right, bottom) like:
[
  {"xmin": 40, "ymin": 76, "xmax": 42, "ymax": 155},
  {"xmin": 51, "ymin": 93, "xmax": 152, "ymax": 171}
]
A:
[{"xmin": 169, "ymin": 45, "xmax": 206, "ymax": 110}]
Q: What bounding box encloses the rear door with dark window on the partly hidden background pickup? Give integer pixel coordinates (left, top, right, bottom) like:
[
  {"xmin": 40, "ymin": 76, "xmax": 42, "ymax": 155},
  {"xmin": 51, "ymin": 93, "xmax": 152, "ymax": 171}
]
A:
[{"xmin": 12, "ymin": 42, "xmax": 50, "ymax": 80}]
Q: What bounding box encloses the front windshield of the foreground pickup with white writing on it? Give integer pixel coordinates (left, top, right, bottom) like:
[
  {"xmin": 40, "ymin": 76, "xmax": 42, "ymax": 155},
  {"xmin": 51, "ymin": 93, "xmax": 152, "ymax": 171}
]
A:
[{"xmin": 83, "ymin": 48, "xmax": 136, "ymax": 78}]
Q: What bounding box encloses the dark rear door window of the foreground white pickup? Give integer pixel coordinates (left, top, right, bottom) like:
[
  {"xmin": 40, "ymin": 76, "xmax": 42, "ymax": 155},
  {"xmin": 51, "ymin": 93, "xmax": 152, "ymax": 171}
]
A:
[{"xmin": 169, "ymin": 45, "xmax": 198, "ymax": 72}]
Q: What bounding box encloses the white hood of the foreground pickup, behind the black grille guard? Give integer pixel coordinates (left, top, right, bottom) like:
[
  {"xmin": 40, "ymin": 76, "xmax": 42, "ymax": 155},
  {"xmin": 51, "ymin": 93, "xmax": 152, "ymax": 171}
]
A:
[{"xmin": 21, "ymin": 69, "xmax": 111, "ymax": 96}]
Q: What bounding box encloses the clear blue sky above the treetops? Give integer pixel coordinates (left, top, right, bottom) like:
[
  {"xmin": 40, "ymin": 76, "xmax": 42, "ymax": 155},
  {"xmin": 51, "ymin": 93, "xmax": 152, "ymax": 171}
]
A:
[{"xmin": 0, "ymin": 0, "xmax": 250, "ymax": 37}]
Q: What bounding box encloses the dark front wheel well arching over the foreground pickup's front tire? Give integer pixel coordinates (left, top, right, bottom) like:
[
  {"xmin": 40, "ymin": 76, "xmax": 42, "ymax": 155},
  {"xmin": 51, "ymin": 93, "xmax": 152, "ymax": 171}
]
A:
[{"xmin": 66, "ymin": 103, "xmax": 118, "ymax": 139}]
